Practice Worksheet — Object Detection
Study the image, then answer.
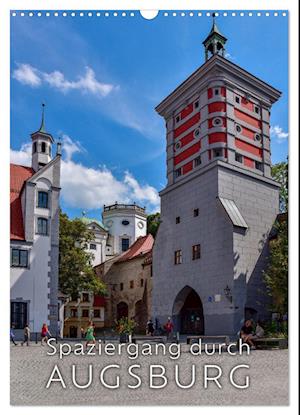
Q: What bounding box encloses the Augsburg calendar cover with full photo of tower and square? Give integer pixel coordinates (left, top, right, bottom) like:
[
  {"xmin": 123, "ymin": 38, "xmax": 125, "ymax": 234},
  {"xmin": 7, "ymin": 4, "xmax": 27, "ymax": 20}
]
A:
[{"xmin": 10, "ymin": 9, "xmax": 289, "ymax": 406}]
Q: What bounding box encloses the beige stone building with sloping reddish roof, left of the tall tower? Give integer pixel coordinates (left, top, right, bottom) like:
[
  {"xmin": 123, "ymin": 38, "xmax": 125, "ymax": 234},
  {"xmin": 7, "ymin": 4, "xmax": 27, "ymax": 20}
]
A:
[{"xmin": 96, "ymin": 235, "xmax": 153, "ymax": 333}]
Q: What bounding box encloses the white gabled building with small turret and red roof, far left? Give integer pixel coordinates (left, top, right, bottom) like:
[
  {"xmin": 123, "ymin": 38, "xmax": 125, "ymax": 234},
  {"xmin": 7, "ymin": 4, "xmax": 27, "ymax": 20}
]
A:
[{"xmin": 10, "ymin": 107, "xmax": 61, "ymax": 338}]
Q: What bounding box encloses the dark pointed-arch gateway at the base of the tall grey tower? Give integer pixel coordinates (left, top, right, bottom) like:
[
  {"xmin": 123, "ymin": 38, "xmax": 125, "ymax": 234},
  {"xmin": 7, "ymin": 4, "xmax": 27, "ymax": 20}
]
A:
[{"xmin": 172, "ymin": 286, "xmax": 204, "ymax": 335}]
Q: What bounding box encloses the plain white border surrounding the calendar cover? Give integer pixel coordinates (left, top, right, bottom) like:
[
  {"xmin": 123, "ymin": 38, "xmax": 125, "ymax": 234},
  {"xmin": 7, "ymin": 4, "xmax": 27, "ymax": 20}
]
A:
[{"xmin": 0, "ymin": 0, "xmax": 299, "ymax": 415}]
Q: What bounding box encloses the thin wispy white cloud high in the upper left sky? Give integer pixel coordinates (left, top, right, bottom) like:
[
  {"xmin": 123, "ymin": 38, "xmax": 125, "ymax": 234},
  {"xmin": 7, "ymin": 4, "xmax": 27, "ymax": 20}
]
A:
[{"xmin": 13, "ymin": 63, "xmax": 118, "ymax": 97}]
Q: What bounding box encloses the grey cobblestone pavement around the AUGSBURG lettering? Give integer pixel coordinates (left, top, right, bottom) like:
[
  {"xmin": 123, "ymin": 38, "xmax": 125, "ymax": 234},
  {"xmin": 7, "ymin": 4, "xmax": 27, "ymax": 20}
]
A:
[{"xmin": 11, "ymin": 344, "xmax": 288, "ymax": 405}]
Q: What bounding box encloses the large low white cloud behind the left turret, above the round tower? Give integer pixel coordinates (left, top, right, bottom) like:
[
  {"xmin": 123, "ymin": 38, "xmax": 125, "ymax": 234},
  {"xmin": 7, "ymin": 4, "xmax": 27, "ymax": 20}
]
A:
[{"xmin": 10, "ymin": 135, "xmax": 159, "ymax": 212}]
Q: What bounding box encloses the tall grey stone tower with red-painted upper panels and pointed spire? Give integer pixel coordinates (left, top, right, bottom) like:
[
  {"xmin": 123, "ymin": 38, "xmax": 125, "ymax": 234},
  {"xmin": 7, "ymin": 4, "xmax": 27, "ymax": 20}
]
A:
[{"xmin": 152, "ymin": 18, "xmax": 280, "ymax": 335}]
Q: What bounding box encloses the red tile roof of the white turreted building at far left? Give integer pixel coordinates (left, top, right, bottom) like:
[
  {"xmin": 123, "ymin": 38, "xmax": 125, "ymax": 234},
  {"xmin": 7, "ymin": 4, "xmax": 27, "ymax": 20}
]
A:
[{"xmin": 10, "ymin": 164, "xmax": 34, "ymax": 241}]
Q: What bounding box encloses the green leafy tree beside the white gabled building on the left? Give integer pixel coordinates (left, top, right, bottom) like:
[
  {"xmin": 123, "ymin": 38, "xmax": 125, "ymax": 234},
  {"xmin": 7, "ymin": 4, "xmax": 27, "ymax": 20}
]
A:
[{"xmin": 59, "ymin": 212, "xmax": 106, "ymax": 296}]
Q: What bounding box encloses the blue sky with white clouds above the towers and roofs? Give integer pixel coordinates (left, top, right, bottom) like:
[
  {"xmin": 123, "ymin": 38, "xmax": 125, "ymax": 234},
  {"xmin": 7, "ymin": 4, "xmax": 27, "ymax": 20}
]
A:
[{"xmin": 11, "ymin": 12, "xmax": 288, "ymax": 221}]
